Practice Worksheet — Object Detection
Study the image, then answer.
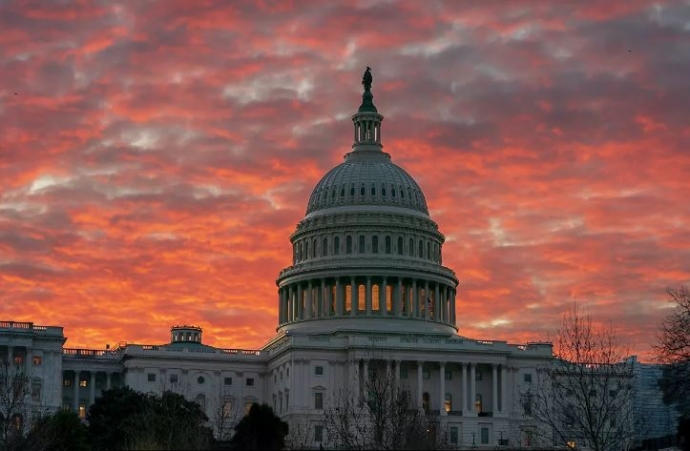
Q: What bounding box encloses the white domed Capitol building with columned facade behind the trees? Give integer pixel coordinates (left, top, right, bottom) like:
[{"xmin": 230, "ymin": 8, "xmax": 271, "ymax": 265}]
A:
[{"xmin": 0, "ymin": 72, "xmax": 553, "ymax": 448}]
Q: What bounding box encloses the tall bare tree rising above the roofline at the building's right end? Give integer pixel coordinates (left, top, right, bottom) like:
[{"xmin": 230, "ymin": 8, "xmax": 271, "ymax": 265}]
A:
[{"xmin": 521, "ymin": 305, "xmax": 634, "ymax": 451}]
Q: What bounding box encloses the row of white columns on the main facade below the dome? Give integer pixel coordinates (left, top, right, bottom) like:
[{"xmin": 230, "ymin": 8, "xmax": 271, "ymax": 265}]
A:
[{"xmin": 350, "ymin": 359, "xmax": 509, "ymax": 416}]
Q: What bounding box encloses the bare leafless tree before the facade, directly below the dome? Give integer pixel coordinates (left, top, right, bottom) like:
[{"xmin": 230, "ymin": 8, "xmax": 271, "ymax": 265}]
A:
[{"xmin": 324, "ymin": 373, "xmax": 440, "ymax": 450}]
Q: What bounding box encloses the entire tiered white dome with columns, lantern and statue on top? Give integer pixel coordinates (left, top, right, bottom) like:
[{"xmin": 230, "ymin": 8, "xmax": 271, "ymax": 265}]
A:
[{"xmin": 276, "ymin": 68, "xmax": 458, "ymax": 336}]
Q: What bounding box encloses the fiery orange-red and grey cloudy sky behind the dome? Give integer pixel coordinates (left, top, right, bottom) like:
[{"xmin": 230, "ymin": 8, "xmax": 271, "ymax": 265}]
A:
[{"xmin": 0, "ymin": 0, "xmax": 690, "ymax": 360}]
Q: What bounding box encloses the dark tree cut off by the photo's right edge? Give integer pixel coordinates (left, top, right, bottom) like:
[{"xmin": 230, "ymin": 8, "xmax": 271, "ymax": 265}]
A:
[{"xmin": 654, "ymin": 287, "xmax": 690, "ymax": 420}]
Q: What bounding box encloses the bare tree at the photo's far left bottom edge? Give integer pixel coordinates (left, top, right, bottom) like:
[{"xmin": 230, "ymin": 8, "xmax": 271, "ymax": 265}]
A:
[{"xmin": 0, "ymin": 361, "xmax": 29, "ymax": 451}]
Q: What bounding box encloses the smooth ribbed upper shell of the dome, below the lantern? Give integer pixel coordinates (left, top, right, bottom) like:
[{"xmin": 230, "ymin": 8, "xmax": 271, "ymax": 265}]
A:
[{"xmin": 307, "ymin": 150, "xmax": 429, "ymax": 215}]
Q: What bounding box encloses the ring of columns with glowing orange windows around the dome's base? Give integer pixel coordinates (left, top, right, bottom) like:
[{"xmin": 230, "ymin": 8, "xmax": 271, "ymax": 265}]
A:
[{"xmin": 278, "ymin": 276, "xmax": 455, "ymax": 324}]
